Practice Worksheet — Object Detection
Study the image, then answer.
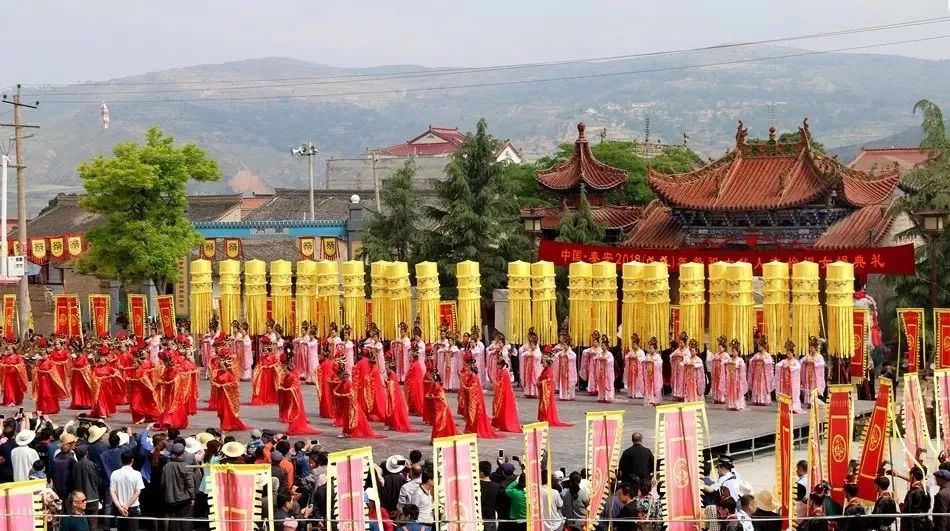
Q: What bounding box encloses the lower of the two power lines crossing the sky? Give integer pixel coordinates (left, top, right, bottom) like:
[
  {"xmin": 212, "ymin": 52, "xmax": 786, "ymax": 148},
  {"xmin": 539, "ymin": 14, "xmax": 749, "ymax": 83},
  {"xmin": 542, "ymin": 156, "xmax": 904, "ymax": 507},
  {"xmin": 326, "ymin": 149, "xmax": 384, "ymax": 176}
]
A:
[{"xmin": 33, "ymin": 34, "xmax": 950, "ymax": 105}]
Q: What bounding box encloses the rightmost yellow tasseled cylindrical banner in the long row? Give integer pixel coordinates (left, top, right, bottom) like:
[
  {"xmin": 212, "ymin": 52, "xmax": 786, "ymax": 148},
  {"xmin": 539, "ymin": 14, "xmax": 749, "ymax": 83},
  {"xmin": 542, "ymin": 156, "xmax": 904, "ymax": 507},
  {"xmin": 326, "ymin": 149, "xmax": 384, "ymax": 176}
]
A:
[{"xmin": 825, "ymin": 262, "xmax": 854, "ymax": 358}]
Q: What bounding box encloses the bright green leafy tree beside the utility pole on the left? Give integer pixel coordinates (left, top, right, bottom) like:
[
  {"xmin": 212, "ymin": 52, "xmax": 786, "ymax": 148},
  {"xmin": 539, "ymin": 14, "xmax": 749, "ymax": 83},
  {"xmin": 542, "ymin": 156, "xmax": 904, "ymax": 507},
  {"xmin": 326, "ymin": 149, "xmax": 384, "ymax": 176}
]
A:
[{"xmin": 77, "ymin": 127, "xmax": 221, "ymax": 293}]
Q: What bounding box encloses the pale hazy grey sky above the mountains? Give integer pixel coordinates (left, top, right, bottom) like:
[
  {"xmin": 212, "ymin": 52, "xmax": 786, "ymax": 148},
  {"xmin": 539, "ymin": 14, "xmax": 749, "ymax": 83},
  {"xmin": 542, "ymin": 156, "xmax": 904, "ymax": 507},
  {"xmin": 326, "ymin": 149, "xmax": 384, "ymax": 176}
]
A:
[{"xmin": 11, "ymin": 0, "xmax": 950, "ymax": 86}]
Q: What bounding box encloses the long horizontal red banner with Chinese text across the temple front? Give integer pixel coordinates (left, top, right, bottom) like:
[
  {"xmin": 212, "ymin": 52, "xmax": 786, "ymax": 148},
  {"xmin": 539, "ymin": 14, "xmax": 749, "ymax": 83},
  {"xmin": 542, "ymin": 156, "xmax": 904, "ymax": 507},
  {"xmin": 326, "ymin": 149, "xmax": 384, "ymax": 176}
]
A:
[{"xmin": 538, "ymin": 240, "xmax": 916, "ymax": 275}]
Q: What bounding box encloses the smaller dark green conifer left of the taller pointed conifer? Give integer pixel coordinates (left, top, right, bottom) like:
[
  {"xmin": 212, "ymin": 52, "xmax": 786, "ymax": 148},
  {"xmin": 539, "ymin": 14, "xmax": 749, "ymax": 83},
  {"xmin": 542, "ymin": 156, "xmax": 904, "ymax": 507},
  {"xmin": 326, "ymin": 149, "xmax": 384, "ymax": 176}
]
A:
[{"xmin": 363, "ymin": 160, "xmax": 422, "ymax": 267}]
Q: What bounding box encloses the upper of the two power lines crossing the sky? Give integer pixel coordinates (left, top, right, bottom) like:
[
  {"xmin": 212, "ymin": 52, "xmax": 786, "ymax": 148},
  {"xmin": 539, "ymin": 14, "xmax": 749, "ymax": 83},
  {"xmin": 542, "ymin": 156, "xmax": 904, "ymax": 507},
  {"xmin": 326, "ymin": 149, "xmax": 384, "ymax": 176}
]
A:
[{"xmin": 18, "ymin": 16, "xmax": 950, "ymax": 96}]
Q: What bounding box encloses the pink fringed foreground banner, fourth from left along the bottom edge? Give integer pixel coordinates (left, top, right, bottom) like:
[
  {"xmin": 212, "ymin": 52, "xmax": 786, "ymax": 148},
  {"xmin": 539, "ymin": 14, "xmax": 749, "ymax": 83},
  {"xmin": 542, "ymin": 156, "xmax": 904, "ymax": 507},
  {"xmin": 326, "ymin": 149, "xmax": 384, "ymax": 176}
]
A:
[{"xmin": 432, "ymin": 434, "xmax": 482, "ymax": 531}]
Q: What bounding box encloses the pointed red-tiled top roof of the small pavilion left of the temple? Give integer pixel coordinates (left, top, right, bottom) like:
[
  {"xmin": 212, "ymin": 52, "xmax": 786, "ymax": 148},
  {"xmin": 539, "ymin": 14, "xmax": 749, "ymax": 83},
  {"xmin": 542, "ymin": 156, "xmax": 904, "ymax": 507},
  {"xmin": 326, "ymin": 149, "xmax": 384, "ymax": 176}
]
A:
[{"xmin": 538, "ymin": 122, "xmax": 627, "ymax": 191}]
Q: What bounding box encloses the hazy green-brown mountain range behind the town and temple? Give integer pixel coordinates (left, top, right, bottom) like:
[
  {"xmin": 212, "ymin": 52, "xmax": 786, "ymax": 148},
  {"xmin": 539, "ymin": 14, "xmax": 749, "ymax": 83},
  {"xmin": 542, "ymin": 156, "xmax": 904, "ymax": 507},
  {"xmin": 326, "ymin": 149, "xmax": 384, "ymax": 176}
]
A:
[{"xmin": 14, "ymin": 46, "xmax": 950, "ymax": 215}]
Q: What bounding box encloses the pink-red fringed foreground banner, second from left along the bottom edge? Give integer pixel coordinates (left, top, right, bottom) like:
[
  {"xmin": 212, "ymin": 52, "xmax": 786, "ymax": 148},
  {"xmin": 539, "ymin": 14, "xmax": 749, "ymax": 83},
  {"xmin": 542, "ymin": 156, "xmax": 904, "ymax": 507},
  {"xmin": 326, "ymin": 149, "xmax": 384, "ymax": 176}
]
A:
[{"xmin": 207, "ymin": 465, "xmax": 274, "ymax": 531}]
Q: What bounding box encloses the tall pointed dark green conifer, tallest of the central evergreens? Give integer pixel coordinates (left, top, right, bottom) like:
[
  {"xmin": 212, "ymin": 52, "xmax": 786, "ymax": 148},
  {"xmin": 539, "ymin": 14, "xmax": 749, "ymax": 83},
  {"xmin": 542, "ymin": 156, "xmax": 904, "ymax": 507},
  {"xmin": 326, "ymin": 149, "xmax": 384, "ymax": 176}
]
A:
[{"xmin": 423, "ymin": 118, "xmax": 531, "ymax": 307}]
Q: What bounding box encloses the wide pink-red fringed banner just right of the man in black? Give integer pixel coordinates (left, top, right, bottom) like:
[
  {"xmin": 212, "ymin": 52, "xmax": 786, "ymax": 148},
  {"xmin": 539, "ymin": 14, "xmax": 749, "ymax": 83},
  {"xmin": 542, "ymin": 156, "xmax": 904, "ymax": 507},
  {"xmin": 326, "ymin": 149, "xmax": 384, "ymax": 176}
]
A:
[{"xmin": 656, "ymin": 402, "xmax": 707, "ymax": 531}]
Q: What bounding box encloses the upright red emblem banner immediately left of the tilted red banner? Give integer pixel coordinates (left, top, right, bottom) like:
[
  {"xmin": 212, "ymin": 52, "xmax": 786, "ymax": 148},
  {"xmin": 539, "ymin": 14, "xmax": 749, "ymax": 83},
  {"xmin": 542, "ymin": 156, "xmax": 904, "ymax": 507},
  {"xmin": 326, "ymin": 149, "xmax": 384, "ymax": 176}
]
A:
[{"xmin": 824, "ymin": 384, "xmax": 854, "ymax": 504}]
